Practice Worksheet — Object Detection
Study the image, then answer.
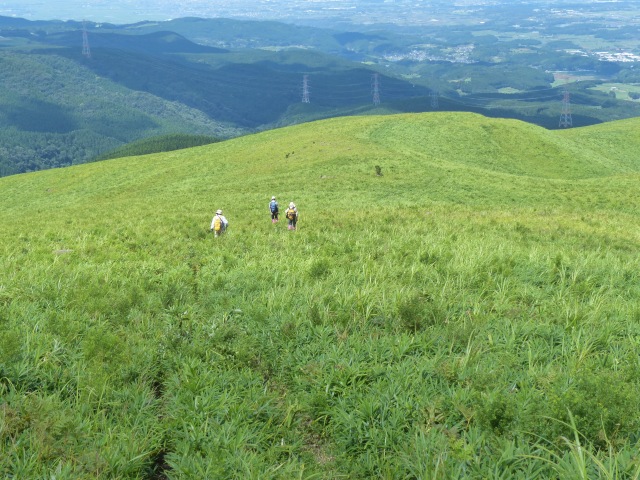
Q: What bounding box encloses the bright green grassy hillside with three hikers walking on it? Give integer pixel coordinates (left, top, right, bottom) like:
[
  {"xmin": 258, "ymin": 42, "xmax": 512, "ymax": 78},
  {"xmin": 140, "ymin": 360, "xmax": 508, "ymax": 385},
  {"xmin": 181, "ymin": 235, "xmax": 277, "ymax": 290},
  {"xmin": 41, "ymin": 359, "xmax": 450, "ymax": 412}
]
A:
[{"xmin": 0, "ymin": 113, "xmax": 640, "ymax": 479}]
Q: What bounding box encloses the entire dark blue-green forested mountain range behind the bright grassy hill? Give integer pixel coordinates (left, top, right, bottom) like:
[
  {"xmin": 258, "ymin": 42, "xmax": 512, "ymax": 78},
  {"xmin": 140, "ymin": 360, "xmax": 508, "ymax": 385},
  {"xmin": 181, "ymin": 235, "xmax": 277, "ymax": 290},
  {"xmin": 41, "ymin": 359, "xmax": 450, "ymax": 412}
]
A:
[{"xmin": 0, "ymin": 17, "xmax": 637, "ymax": 175}]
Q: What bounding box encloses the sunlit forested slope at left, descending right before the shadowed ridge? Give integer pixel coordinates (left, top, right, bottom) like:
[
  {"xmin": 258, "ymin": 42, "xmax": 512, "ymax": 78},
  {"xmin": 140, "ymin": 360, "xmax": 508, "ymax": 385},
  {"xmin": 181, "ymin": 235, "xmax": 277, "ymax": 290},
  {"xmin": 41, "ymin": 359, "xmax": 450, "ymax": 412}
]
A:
[{"xmin": 0, "ymin": 51, "xmax": 244, "ymax": 175}]
